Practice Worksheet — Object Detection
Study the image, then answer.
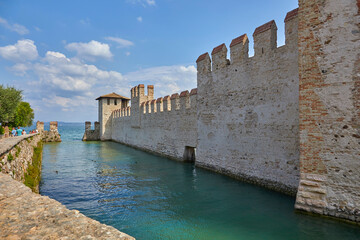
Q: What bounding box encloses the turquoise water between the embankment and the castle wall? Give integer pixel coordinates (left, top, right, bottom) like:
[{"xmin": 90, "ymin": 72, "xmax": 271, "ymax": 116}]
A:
[{"xmin": 40, "ymin": 123, "xmax": 360, "ymax": 240}]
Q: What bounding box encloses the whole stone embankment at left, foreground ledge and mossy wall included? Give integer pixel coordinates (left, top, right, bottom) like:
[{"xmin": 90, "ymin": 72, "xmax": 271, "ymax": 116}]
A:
[{"xmin": 0, "ymin": 127, "xmax": 134, "ymax": 240}]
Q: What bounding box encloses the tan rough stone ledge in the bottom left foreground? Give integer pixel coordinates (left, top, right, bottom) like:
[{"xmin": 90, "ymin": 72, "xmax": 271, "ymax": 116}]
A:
[{"xmin": 0, "ymin": 173, "xmax": 135, "ymax": 240}]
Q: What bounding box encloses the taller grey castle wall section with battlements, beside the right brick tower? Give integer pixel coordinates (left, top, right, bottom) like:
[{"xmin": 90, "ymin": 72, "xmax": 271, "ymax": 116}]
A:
[{"xmin": 196, "ymin": 10, "xmax": 299, "ymax": 195}]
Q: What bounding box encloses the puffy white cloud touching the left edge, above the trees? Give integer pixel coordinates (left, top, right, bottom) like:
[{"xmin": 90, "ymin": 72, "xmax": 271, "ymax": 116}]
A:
[{"xmin": 0, "ymin": 39, "xmax": 38, "ymax": 62}]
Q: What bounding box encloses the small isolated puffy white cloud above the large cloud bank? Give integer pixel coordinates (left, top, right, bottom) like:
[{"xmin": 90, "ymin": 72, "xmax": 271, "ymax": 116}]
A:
[{"xmin": 65, "ymin": 40, "xmax": 113, "ymax": 61}]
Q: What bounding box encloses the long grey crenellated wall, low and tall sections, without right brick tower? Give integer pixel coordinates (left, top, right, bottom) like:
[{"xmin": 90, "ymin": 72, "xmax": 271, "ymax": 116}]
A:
[{"xmin": 99, "ymin": 10, "xmax": 299, "ymax": 195}]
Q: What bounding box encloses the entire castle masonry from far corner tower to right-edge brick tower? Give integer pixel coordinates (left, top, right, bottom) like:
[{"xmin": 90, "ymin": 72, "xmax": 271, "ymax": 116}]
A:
[{"xmin": 86, "ymin": 0, "xmax": 360, "ymax": 222}]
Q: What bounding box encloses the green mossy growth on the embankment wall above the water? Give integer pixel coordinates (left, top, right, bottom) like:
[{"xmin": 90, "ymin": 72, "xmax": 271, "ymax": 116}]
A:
[{"xmin": 24, "ymin": 141, "xmax": 43, "ymax": 193}]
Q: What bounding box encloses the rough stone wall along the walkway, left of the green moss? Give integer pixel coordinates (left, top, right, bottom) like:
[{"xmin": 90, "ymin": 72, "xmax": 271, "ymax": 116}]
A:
[{"xmin": 0, "ymin": 134, "xmax": 41, "ymax": 189}]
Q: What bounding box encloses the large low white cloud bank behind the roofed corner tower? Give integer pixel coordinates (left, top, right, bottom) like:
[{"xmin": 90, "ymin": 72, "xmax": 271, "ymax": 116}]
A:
[{"xmin": 0, "ymin": 40, "xmax": 196, "ymax": 121}]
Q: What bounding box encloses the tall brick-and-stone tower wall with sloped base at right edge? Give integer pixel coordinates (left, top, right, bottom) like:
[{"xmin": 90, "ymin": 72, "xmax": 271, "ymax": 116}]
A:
[{"xmin": 295, "ymin": 0, "xmax": 360, "ymax": 221}]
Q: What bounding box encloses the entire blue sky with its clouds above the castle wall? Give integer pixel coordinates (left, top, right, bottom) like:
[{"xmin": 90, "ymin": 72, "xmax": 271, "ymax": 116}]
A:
[{"xmin": 0, "ymin": 0, "xmax": 298, "ymax": 122}]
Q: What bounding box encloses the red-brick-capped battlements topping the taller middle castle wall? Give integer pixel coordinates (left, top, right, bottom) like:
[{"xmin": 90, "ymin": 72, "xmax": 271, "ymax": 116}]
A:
[{"xmin": 196, "ymin": 9, "xmax": 298, "ymax": 74}]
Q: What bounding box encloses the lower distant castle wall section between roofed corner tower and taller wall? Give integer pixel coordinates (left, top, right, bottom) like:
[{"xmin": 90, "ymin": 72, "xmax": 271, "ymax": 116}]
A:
[{"xmin": 111, "ymin": 85, "xmax": 197, "ymax": 161}]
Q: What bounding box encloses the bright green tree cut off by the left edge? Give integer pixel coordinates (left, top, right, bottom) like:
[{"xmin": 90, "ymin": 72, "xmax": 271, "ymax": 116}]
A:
[{"xmin": 0, "ymin": 85, "xmax": 22, "ymax": 125}]
